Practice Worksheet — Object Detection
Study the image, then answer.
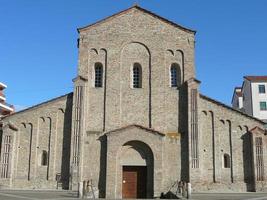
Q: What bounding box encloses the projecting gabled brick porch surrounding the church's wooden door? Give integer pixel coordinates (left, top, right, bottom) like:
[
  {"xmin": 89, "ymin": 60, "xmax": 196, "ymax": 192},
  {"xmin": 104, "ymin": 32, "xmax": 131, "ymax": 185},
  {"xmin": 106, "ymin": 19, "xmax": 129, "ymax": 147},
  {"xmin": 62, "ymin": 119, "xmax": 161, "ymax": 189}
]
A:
[{"xmin": 105, "ymin": 124, "xmax": 165, "ymax": 199}]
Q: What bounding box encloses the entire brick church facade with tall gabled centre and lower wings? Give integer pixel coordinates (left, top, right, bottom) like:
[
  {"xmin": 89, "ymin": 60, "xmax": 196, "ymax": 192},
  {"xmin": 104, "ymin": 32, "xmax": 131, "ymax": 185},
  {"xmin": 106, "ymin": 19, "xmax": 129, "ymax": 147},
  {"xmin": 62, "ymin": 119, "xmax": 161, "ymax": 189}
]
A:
[{"xmin": 0, "ymin": 6, "xmax": 267, "ymax": 198}]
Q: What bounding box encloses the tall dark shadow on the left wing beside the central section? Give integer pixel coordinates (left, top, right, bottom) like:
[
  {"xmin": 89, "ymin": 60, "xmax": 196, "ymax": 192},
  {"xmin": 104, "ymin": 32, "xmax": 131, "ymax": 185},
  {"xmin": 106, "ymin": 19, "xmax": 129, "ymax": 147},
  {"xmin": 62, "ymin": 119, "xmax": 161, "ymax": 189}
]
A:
[{"xmin": 61, "ymin": 94, "xmax": 72, "ymax": 190}]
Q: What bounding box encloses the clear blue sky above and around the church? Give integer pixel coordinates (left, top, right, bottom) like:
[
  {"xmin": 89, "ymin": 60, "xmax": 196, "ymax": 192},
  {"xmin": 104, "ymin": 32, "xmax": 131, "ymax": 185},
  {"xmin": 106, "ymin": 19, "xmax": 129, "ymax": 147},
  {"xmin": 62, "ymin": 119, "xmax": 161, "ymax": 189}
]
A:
[{"xmin": 0, "ymin": 0, "xmax": 267, "ymax": 109}]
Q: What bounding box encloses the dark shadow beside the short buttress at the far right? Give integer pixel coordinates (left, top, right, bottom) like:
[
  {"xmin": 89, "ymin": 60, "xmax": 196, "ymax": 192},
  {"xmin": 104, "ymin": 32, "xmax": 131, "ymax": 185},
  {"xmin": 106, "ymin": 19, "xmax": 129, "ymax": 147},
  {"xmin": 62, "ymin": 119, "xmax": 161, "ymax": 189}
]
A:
[{"xmin": 241, "ymin": 131, "xmax": 255, "ymax": 192}]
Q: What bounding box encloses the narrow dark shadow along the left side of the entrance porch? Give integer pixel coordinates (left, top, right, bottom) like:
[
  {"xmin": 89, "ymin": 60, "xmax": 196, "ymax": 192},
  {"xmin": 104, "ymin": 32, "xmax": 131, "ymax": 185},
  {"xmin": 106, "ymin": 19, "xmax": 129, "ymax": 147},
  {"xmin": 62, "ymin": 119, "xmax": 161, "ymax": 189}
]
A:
[{"xmin": 98, "ymin": 135, "xmax": 107, "ymax": 198}]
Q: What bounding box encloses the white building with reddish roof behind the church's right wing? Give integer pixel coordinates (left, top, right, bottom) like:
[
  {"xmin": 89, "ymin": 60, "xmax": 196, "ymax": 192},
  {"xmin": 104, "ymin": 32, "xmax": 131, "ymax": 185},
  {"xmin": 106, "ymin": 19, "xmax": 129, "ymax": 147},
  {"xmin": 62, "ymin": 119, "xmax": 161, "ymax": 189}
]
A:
[{"xmin": 232, "ymin": 76, "xmax": 267, "ymax": 122}]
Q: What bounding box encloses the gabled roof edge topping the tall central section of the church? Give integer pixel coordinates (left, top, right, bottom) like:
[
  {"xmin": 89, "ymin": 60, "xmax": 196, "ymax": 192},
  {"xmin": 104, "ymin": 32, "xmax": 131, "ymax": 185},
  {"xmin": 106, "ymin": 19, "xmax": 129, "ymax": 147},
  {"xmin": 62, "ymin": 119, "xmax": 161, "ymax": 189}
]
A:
[{"xmin": 77, "ymin": 5, "xmax": 196, "ymax": 34}]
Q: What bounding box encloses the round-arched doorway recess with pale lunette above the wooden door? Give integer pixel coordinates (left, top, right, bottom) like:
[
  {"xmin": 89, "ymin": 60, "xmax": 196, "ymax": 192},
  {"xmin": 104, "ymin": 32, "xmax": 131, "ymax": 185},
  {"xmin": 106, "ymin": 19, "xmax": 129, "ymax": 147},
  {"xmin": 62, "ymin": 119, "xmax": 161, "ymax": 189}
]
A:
[{"xmin": 119, "ymin": 141, "xmax": 154, "ymax": 198}]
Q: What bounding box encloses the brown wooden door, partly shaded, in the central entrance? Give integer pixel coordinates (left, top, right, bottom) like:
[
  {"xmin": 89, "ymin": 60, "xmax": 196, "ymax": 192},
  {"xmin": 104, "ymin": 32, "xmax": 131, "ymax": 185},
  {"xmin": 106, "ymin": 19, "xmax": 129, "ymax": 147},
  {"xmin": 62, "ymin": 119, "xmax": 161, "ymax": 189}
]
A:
[{"xmin": 122, "ymin": 166, "xmax": 147, "ymax": 198}]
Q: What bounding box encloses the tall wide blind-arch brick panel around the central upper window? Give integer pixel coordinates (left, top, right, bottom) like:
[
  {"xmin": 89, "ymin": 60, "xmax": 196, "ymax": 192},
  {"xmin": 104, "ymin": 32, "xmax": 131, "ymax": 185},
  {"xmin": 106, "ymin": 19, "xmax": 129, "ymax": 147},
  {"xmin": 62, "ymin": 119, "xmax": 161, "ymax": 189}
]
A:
[{"xmin": 120, "ymin": 41, "xmax": 152, "ymax": 128}]
